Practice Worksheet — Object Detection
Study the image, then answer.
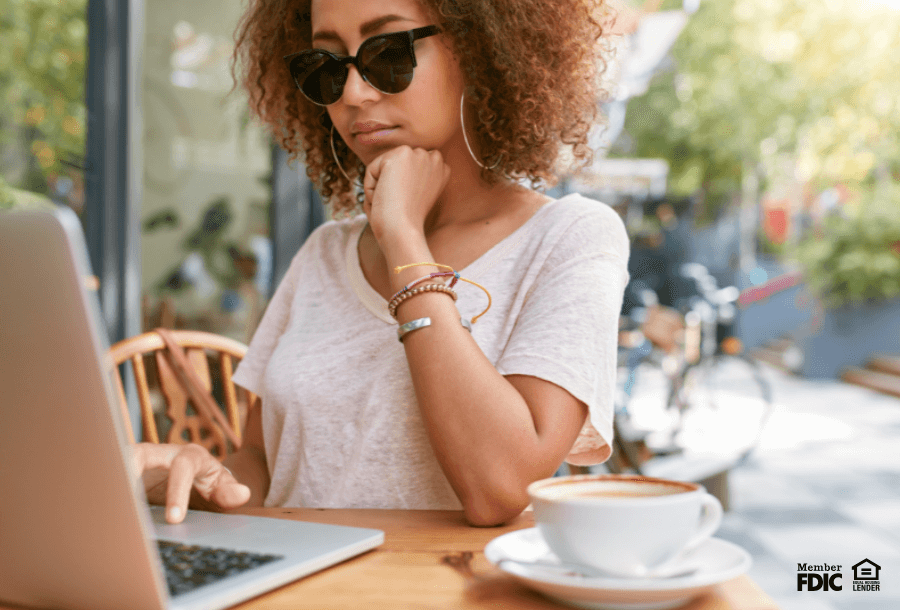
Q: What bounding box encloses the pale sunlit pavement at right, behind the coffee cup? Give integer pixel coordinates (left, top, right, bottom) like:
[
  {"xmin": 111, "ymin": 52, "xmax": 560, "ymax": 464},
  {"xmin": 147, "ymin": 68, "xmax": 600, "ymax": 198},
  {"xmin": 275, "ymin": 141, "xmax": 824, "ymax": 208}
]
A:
[{"xmin": 716, "ymin": 368, "xmax": 900, "ymax": 610}]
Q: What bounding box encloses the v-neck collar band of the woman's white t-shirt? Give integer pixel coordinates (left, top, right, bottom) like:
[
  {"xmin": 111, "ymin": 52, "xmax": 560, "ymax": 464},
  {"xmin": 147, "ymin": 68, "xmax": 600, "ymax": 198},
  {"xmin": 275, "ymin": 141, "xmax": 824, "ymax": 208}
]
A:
[{"xmin": 344, "ymin": 193, "xmax": 575, "ymax": 325}]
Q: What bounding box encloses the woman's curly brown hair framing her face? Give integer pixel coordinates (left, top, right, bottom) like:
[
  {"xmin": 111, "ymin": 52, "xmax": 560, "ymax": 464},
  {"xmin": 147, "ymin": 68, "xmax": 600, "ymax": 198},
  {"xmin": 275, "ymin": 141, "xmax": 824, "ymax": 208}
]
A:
[{"xmin": 232, "ymin": 0, "xmax": 605, "ymax": 214}]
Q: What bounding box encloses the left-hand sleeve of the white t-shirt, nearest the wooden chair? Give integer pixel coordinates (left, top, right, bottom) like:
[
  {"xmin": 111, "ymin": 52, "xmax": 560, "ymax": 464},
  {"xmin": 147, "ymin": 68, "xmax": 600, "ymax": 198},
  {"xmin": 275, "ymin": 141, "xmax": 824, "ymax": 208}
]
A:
[{"xmin": 233, "ymin": 236, "xmax": 304, "ymax": 396}]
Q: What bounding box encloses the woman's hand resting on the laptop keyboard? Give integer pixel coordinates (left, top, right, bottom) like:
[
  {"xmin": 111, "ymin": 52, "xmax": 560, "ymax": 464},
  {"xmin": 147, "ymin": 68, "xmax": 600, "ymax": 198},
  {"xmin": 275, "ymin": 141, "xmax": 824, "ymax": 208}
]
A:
[{"xmin": 132, "ymin": 443, "xmax": 250, "ymax": 523}]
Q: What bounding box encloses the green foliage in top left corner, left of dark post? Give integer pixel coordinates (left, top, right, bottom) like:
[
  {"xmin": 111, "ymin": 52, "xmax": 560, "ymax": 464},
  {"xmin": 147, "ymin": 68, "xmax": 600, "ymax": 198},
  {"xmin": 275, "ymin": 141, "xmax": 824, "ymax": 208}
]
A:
[{"xmin": 0, "ymin": 0, "xmax": 87, "ymax": 191}]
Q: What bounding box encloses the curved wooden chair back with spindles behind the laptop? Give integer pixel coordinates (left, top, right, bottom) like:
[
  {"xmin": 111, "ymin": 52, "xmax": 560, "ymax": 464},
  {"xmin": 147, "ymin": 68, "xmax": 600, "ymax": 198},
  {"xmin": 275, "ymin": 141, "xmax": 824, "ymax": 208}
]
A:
[{"xmin": 109, "ymin": 330, "xmax": 256, "ymax": 459}]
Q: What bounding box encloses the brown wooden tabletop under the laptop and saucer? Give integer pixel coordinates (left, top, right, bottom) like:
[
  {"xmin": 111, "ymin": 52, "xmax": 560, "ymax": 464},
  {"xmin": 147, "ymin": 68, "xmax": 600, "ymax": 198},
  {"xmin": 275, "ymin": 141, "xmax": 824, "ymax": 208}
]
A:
[{"xmin": 227, "ymin": 508, "xmax": 777, "ymax": 610}]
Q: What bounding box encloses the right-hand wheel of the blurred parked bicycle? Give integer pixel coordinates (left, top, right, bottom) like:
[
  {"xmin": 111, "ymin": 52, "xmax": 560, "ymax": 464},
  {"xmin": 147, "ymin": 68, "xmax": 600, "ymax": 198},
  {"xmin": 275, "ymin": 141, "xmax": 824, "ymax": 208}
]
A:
[{"xmin": 675, "ymin": 354, "xmax": 772, "ymax": 460}]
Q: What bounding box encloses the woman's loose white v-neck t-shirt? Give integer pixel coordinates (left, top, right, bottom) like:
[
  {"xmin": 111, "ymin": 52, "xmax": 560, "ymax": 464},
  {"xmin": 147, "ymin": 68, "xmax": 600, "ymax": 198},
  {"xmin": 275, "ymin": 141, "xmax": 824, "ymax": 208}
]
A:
[{"xmin": 234, "ymin": 194, "xmax": 628, "ymax": 509}]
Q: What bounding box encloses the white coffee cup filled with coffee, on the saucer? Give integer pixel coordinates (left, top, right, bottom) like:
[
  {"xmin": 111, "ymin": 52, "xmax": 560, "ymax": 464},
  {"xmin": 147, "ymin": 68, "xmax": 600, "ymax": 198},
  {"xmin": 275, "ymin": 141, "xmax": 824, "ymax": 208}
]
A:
[{"xmin": 528, "ymin": 475, "xmax": 722, "ymax": 578}]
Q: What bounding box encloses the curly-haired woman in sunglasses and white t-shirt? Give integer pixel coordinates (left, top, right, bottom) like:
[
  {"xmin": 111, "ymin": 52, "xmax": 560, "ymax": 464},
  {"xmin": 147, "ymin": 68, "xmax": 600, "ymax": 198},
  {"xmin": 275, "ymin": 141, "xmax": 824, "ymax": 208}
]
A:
[{"xmin": 135, "ymin": 0, "xmax": 628, "ymax": 525}]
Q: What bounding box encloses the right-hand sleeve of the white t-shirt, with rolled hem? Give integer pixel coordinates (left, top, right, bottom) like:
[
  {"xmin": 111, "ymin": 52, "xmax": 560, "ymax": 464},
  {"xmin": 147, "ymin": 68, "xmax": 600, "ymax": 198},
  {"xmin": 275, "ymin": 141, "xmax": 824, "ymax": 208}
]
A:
[{"xmin": 497, "ymin": 202, "xmax": 629, "ymax": 465}]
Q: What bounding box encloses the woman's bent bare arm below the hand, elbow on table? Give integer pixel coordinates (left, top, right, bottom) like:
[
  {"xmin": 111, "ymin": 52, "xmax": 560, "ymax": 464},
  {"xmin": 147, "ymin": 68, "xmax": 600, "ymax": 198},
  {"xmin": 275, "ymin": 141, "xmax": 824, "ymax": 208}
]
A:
[{"xmin": 386, "ymin": 233, "xmax": 586, "ymax": 525}]
